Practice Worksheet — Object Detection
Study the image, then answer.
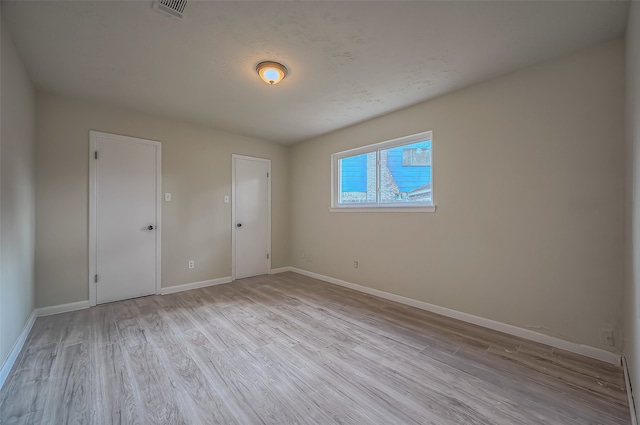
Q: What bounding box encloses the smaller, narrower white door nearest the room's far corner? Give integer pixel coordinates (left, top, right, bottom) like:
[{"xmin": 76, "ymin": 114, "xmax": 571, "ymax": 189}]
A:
[{"xmin": 232, "ymin": 155, "xmax": 271, "ymax": 279}]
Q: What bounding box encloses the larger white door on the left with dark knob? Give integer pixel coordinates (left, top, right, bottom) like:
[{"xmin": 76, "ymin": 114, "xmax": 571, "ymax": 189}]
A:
[{"xmin": 90, "ymin": 131, "xmax": 161, "ymax": 304}]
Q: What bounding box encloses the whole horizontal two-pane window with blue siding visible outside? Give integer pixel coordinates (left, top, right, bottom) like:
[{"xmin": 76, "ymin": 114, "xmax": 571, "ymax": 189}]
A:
[{"xmin": 331, "ymin": 131, "xmax": 435, "ymax": 211}]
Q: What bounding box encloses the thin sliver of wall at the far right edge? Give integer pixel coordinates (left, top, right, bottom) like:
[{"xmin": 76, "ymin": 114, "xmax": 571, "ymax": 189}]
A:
[{"xmin": 624, "ymin": 2, "xmax": 640, "ymax": 418}]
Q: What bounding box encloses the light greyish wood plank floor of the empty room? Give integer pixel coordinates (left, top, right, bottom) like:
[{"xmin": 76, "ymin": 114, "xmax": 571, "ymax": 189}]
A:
[{"xmin": 0, "ymin": 273, "xmax": 630, "ymax": 425}]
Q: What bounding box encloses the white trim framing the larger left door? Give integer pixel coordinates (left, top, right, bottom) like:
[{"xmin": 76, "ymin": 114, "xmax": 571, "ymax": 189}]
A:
[{"xmin": 88, "ymin": 130, "xmax": 162, "ymax": 306}]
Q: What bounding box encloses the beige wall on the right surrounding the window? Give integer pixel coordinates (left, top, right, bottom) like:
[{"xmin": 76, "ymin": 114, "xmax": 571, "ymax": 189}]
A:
[{"xmin": 290, "ymin": 40, "xmax": 624, "ymax": 352}]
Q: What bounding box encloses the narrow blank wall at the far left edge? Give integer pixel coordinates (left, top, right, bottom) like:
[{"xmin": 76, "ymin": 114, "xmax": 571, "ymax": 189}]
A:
[{"xmin": 0, "ymin": 21, "xmax": 35, "ymax": 366}]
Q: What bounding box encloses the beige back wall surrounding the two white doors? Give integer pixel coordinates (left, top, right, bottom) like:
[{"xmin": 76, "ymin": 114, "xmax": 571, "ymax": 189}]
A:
[{"xmin": 36, "ymin": 93, "xmax": 289, "ymax": 307}]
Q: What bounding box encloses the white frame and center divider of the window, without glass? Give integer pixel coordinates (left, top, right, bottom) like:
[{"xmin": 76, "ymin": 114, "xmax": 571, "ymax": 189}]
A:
[{"xmin": 329, "ymin": 130, "xmax": 436, "ymax": 212}]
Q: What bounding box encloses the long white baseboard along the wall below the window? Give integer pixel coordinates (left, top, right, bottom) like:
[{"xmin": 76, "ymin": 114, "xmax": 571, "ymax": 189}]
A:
[{"xmin": 289, "ymin": 267, "xmax": 621, "ymax": 366}]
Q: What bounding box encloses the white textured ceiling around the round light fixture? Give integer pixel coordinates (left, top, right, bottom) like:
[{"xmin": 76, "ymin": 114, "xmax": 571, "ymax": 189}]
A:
[{"xmin": 2, "ymin": 0, "xmax": 628, "ymax": 143}]
